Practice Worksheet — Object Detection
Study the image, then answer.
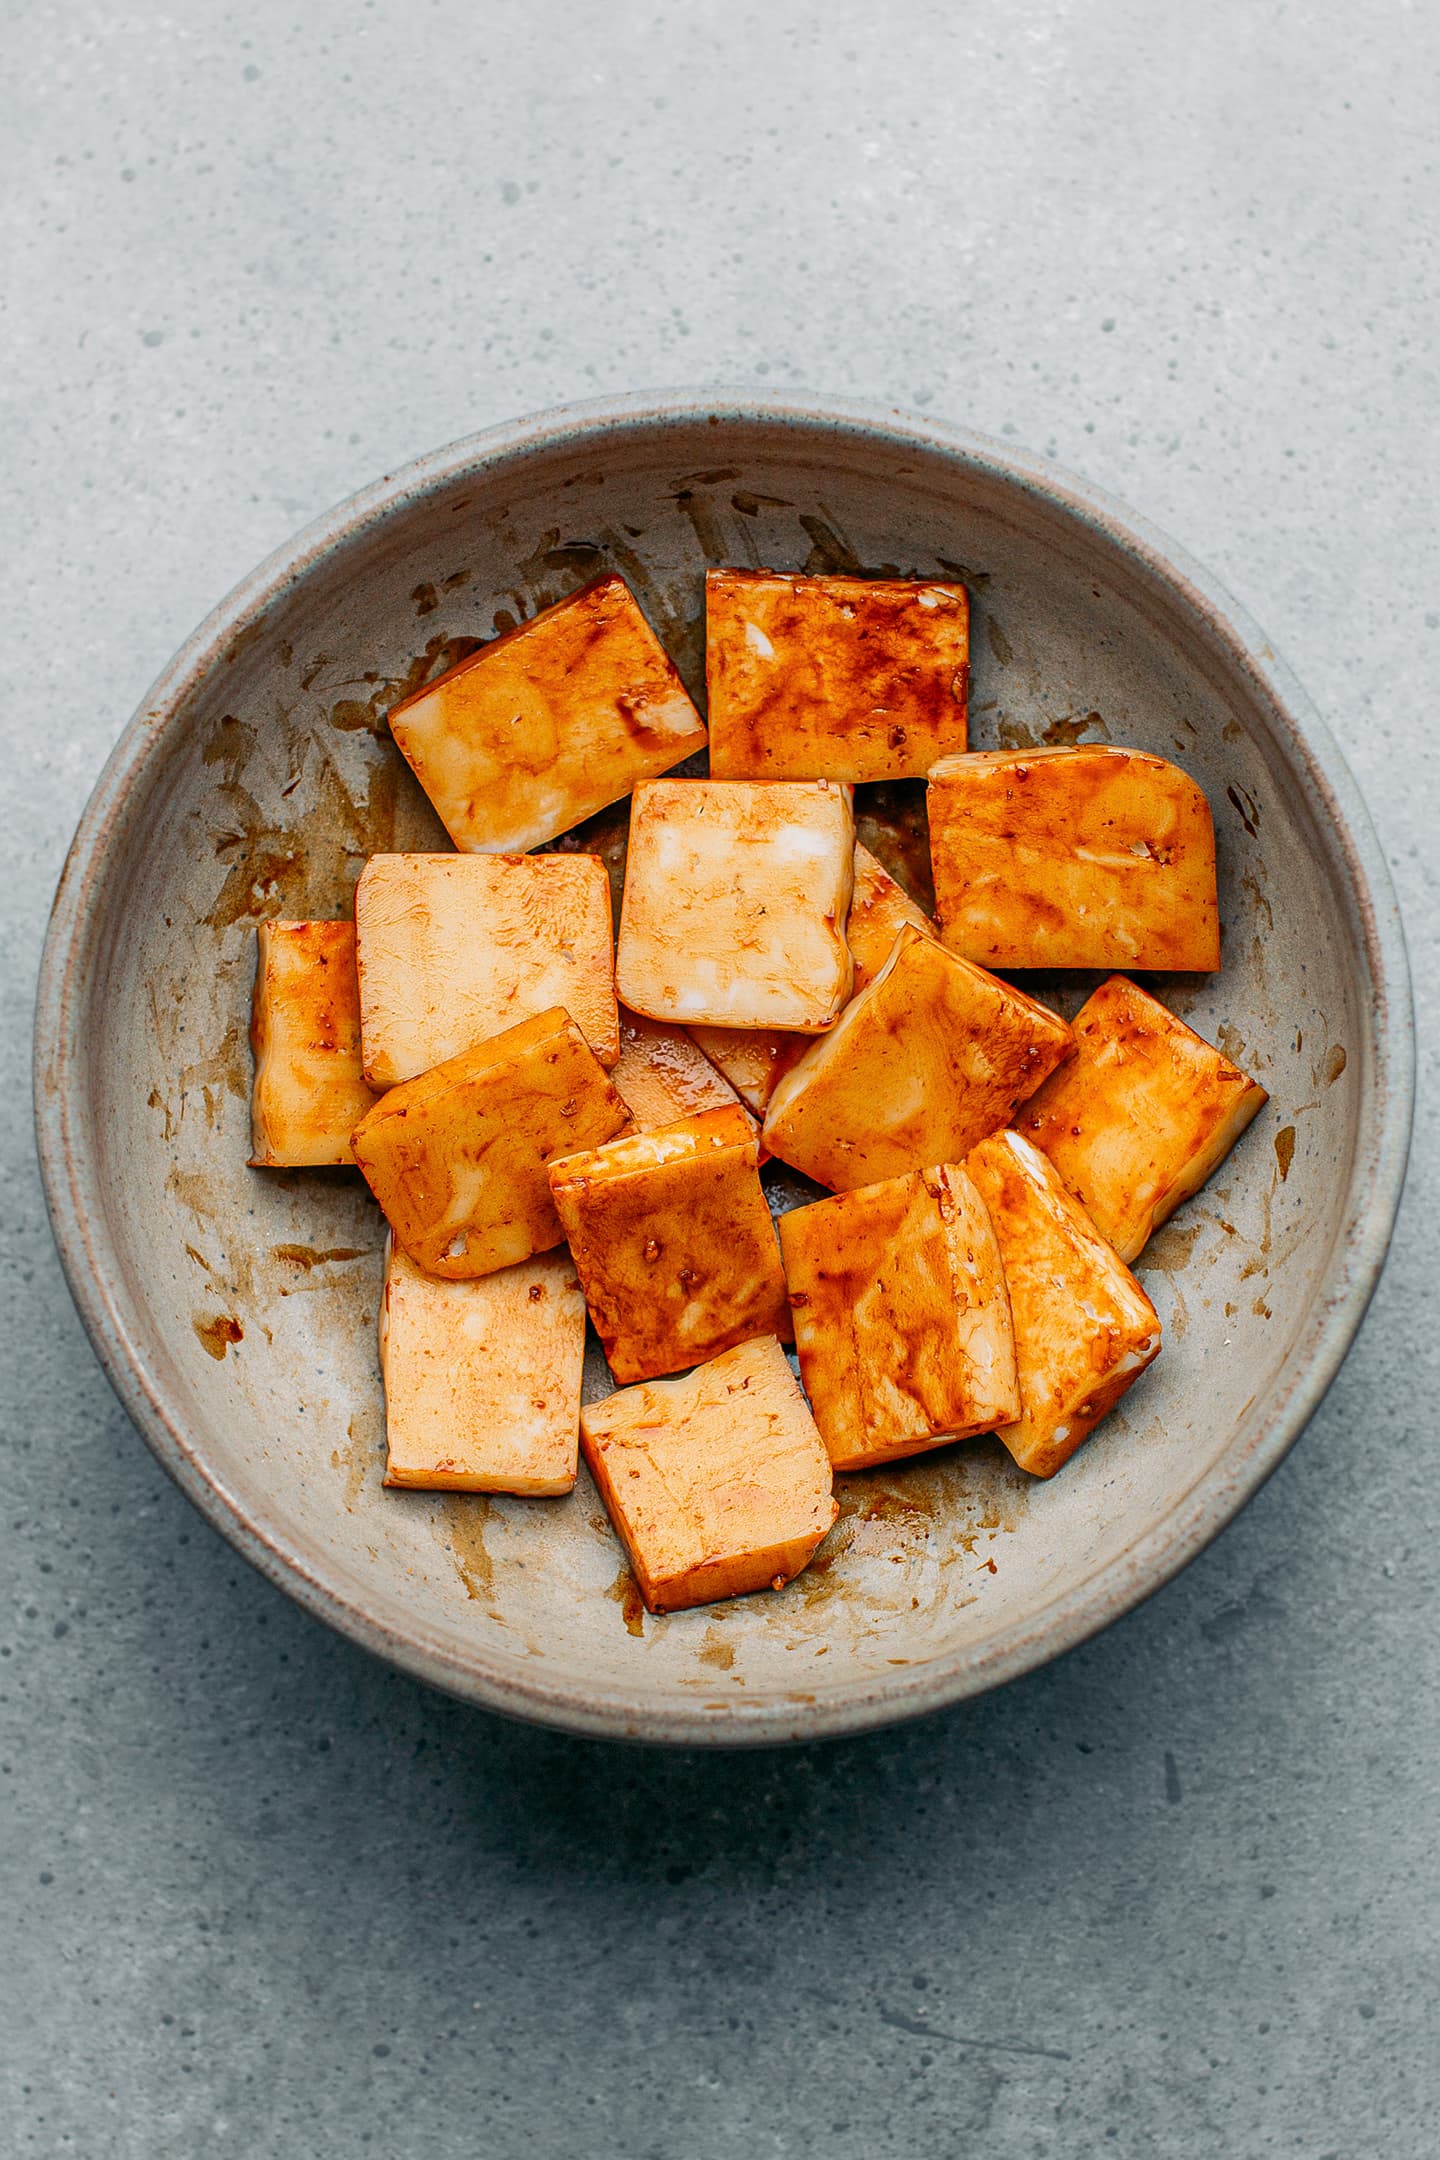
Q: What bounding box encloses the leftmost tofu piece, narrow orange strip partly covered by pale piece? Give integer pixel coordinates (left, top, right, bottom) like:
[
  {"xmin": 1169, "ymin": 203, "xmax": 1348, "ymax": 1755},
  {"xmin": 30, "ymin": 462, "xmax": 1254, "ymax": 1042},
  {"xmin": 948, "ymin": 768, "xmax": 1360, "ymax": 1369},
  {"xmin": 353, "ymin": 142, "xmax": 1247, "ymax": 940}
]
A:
[{"xmin": 250, "ymin": 922, "xmax": 376, "ymax": 1171}]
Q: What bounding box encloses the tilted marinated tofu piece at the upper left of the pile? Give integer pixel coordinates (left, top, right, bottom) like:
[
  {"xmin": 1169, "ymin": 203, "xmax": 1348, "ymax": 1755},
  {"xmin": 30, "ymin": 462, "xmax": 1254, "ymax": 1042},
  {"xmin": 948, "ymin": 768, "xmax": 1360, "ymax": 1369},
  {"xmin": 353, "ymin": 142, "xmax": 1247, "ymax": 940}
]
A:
[{"xmin": 391, "ymin": 575, "xmax": 706, "ymax": 855}]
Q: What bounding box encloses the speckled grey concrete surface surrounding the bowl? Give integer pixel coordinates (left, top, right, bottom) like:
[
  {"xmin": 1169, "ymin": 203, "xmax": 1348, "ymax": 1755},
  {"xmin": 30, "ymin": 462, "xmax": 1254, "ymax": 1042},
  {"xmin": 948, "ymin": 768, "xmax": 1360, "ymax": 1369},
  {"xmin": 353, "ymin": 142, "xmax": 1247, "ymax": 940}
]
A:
[{"xmin": 0, "ymin": 0, "xmax": 1440, "ymax": 2160}]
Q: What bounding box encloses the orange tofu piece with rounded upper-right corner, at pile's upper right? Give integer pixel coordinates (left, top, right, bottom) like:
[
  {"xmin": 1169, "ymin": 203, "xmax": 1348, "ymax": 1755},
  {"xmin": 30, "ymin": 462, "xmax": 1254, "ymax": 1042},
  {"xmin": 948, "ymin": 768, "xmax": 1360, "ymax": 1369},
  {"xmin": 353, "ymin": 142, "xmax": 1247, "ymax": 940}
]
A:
[{"xmin": 928, "ymin": 743, "xmax": 1220, "ymax": 970}]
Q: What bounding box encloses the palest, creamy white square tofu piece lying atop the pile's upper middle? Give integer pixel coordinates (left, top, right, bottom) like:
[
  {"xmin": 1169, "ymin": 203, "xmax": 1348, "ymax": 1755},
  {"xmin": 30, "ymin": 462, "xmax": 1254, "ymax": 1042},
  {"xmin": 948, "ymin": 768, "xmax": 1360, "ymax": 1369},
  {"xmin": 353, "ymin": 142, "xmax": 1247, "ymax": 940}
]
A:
[{"xmin": 615, "ymin": 780, "xmax": 855, "ymax": 1035}]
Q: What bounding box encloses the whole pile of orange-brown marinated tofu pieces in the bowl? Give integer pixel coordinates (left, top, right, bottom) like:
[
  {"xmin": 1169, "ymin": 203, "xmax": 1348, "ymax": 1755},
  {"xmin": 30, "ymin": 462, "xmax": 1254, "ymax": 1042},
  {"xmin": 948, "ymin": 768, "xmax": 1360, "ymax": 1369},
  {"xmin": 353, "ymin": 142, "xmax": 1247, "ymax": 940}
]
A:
[{"xmin": 253, "ymin": 570, "xmax": 1265, "ymax": 1611}]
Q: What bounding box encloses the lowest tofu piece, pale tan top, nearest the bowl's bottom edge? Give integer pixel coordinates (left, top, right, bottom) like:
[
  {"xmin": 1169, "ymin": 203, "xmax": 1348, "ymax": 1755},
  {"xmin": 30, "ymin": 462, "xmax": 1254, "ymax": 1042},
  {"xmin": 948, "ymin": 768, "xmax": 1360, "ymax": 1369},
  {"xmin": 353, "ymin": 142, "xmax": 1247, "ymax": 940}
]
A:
[{"xmin": 581, "ymin": 1335, "xmax": 840, "ymax": 1614}]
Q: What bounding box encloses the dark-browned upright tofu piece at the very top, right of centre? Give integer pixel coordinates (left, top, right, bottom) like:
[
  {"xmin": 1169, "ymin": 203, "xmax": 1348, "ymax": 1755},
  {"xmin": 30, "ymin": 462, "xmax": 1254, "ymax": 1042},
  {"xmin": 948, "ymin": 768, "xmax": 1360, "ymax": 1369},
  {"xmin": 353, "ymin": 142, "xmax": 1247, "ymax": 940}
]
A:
[{"xmin": 706, "ymin": 570, "xmax": 969, "ymax": 780}]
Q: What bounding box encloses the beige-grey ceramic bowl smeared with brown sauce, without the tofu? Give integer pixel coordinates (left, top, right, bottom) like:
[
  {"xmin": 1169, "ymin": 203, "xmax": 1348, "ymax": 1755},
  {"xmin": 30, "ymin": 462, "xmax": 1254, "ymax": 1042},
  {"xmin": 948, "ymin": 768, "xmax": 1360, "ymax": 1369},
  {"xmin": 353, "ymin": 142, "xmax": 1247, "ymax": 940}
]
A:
[{"xmin": 37, "ymin": 393, "xmax": 1412, "ymax": 1743}]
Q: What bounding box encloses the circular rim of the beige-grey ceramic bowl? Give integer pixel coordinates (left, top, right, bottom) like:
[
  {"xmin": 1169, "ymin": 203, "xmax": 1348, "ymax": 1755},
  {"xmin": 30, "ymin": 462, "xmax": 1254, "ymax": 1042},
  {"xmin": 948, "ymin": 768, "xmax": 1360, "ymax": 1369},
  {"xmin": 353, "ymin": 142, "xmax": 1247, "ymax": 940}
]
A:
[{"xmin": 35, "ymin": 389, "xmax": 1414, "ymax": 1745}]
